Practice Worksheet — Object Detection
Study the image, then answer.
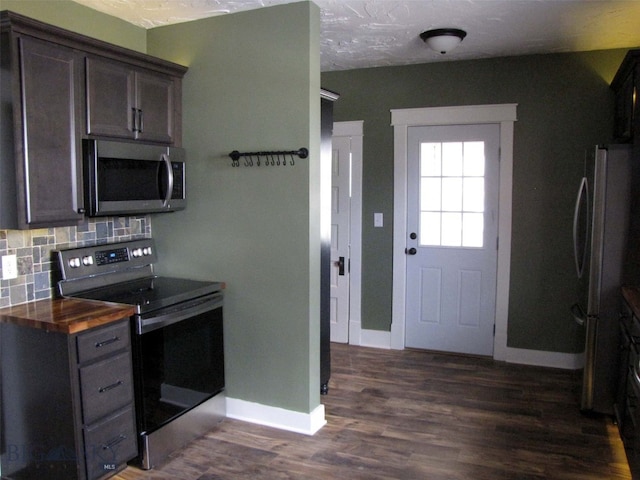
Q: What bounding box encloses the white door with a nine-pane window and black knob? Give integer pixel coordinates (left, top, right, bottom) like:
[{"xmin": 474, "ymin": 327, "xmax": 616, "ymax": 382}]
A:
[{"xmin": 405, "ymin": 124, "xmax": 500, "ymax": 355}]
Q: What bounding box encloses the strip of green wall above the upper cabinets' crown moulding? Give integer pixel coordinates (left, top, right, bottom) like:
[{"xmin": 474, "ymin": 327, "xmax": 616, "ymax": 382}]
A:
[{"xmin": 0, "ymin": 0, "xmax": 147, "ymax": 52}]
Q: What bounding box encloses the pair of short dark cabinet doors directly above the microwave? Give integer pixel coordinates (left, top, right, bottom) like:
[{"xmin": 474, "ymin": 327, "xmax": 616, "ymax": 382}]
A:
[{"xmin": 87, "ymin": 57, "xmax": 176, "ymax": 144}]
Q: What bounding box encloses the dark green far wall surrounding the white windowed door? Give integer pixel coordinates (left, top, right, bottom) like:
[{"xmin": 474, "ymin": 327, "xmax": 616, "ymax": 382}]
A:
[{"xmin": 321, "ymin": 50, "xmax": 626, "ymax": 353}]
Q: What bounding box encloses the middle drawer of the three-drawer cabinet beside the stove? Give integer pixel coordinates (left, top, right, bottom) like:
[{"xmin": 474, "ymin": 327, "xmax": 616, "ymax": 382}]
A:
[{"xmin": 80, "ymin": 351, "xmax": 133, "ymax": 424}]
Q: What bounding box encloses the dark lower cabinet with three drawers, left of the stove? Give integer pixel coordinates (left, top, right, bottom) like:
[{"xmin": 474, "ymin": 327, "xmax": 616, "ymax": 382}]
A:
[{"xmin": 0, "ymin": 318, "xmax": 137, "ymax": 480}]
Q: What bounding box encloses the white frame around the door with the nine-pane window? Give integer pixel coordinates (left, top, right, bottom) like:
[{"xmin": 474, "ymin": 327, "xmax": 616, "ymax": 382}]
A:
[{"xmin": 391, "ymin": 103, "xmax": 517, "ymax": 360}]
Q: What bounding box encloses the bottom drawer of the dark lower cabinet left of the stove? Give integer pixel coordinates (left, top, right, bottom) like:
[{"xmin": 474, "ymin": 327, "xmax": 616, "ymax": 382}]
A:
[{"xmin": 84, "ymin": 406, "xmax": 138, "ymax": 480}]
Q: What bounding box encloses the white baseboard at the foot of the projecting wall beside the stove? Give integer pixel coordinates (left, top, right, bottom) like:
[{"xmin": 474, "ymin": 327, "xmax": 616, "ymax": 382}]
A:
[{"xmin": 227, "ymin": 397, "xmax": 327, "ymax": 435}]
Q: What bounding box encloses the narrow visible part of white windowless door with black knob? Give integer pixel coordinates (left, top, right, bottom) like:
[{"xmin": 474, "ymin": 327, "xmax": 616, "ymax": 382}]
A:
[{"xmin": 331, "ymin": 136, "xmax": 351, "ymax": 343}]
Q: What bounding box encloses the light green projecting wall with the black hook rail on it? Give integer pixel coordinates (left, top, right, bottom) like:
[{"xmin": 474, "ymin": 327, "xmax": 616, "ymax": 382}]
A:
[{"xmin": 148, "ymin": 2, "xmax": 320, "ymax": 412}]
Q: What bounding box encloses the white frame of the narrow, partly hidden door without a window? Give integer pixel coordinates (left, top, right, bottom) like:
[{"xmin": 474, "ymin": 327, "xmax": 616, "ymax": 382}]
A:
[{"xmin": 332, "ymin": 120, "xmax": 364, "ymax": 345}]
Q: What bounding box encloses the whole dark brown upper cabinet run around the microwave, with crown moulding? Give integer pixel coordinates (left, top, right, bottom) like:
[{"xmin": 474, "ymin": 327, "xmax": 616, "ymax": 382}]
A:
[{"xmin": 0, "ymin": 11, "xmax": 187, "ymax": 229}]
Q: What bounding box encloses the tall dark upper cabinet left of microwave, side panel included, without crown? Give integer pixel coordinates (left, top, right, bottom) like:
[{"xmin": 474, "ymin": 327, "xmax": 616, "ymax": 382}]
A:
[{"xmin": 0, "ymin": 34, "xmax": 84, "ymax": 229}]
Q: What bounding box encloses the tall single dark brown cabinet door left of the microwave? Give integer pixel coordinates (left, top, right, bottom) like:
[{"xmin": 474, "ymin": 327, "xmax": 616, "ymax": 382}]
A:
[{"xmin": 16, "ymin": 36, "xmax": 84, "ymax": 228}]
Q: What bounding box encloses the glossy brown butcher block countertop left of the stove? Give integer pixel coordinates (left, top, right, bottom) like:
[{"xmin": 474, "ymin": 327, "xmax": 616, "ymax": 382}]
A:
[{"xmin": 0, "ymin": 298, "xmax": 134, "ymax": 334}]
